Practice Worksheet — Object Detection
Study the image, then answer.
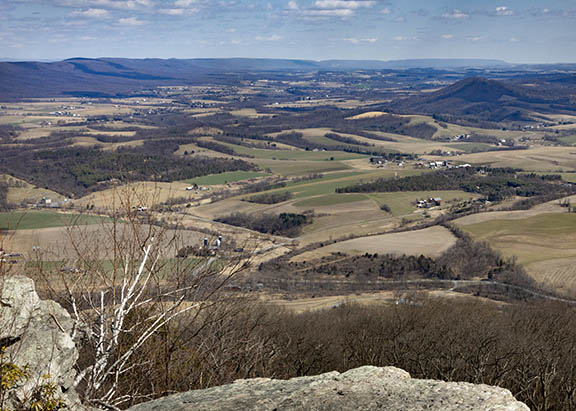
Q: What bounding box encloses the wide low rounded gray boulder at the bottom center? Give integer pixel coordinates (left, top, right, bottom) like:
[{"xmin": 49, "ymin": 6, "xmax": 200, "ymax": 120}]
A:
[{"xmin": 129, "ymin": 366, "xmax": 529, "ymax": 411}]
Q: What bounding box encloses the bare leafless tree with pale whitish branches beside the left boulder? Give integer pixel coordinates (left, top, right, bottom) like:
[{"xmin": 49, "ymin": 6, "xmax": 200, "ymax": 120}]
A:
[{"xmin": 31, "ymin": 186, "xmax": 246, "ymax": 409}]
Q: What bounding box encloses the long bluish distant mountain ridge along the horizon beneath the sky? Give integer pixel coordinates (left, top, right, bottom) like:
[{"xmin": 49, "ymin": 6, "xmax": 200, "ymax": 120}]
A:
[{"xmin": 0, "ymin": 57, "xmax": 576, "ymax": 99}]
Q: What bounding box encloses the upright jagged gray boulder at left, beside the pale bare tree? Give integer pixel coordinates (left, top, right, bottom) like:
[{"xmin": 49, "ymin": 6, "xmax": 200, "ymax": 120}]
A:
[{"xmin": 0, "ymin": 276, "xmax": 82, "ymax": 409}]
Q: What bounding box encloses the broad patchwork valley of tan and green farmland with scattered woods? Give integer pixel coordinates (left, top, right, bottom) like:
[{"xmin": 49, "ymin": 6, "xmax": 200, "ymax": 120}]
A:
[{"xmin": 0, "ymin": 62, "xmax": 576, "ymax": 306}]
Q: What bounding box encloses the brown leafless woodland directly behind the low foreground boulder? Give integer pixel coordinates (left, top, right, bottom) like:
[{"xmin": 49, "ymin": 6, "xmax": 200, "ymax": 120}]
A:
[{"xmin": 111, "ymin": 294, "xmax": 576, "ymax": 411}]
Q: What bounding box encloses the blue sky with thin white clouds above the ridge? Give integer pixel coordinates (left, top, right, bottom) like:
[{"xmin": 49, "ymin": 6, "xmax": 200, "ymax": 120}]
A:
[{"xmin": 0, "ymin": 0, "xmax": 576, "ymax": 63}]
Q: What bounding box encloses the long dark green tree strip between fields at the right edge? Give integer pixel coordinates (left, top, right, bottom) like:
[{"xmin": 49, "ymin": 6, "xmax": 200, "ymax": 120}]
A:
[{"xmin": 336, "ymin": 168, "xmax": 576, "ymax": 201}]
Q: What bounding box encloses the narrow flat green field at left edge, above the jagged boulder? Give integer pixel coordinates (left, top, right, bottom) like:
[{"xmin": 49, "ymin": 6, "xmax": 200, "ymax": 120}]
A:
[{"xmin": 0, "ymin": 211, "xmax": 107, "ymax": 230}]
